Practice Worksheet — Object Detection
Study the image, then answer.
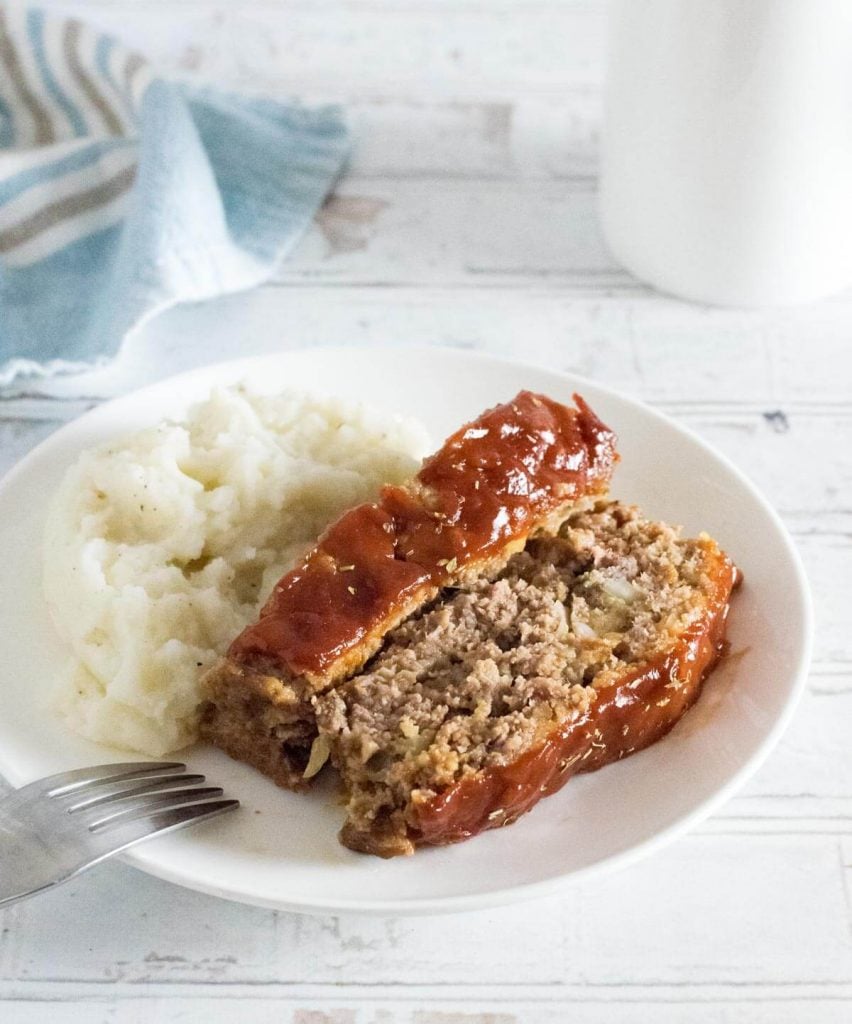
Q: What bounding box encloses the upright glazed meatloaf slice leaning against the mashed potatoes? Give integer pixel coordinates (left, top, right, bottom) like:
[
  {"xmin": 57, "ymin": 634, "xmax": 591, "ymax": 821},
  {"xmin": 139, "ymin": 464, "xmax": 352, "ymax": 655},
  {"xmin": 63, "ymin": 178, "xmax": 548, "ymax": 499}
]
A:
[{"xmin": 201, "ymin": 391, "xmax": 615, "ymax": 788}]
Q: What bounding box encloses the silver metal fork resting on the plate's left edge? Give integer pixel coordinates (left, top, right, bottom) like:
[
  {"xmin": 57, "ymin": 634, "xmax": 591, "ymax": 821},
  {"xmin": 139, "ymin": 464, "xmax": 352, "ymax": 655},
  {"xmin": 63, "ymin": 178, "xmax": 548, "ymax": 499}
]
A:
[{"xmin": 0, "ymin": 761, "xmax": 240, "ymax": 907}]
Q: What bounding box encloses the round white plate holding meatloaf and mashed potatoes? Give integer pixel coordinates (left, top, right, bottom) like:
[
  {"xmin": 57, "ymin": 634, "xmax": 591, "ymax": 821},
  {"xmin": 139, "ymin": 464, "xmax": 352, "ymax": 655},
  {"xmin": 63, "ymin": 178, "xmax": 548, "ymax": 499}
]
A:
[{"xmin": 0, "ymin": 348, "xmax": 811, "ymax": 913}]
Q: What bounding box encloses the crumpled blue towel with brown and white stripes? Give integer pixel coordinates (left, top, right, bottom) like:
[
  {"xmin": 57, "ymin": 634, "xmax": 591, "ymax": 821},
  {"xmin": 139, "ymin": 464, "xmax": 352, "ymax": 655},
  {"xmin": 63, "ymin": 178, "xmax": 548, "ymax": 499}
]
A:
[{"xmin": 0, "ymin": 4, "xmax": 348, "ymax": 385}]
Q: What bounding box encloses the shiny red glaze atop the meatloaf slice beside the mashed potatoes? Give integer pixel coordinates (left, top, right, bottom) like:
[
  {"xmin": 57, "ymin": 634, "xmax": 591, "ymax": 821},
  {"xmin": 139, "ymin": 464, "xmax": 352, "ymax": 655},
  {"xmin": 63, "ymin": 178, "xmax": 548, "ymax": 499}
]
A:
[{"xmin": 228, "ymin": 391, "xmax": 615, "ymax": 675}]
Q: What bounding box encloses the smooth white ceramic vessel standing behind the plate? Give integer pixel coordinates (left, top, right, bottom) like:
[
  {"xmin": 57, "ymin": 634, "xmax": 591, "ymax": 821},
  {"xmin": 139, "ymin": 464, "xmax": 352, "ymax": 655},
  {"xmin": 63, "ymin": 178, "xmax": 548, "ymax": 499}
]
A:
[{"xmin": 600, "ymin": 0, "xmax": 852, "ymax": 305}]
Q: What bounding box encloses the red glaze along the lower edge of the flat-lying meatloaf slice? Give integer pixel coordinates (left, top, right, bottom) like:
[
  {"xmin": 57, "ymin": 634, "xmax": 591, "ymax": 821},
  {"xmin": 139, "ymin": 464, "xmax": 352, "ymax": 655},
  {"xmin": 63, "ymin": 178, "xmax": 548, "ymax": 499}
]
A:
[{"xmin": 411, "ymin": 559, "xmax": 738, "ymax": 846}]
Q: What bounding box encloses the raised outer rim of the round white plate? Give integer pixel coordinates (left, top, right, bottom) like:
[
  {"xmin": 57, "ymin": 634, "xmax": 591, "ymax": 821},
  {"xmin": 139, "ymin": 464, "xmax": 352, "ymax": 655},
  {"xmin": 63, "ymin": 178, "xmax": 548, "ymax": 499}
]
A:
[{"xmin": 0, "ymin": 343, "xmax": 814, "ymax": 915}]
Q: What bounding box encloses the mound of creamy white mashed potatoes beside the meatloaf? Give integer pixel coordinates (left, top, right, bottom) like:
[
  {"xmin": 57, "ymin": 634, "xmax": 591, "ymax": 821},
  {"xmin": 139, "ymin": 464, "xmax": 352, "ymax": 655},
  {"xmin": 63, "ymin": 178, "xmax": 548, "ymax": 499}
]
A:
[{"xmin": 45, "ymin": 388, "xmax": 427, "ymax": 756}]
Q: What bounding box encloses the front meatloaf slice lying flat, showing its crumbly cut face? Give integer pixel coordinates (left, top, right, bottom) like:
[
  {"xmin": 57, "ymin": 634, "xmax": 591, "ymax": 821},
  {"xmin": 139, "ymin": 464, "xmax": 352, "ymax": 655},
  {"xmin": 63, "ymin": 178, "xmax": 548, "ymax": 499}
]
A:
[{"xmin": 316, "ymin": 502, "xmax": 737, "ymax": 857}]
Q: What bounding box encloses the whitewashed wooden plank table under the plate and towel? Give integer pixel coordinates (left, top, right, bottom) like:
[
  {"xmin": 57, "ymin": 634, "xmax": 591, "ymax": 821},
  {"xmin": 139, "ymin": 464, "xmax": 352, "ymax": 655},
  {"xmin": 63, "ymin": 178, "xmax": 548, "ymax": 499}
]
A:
[{"xmin": 0, "ymin": 0, "xmax": 852, "ymax": 1024}]
